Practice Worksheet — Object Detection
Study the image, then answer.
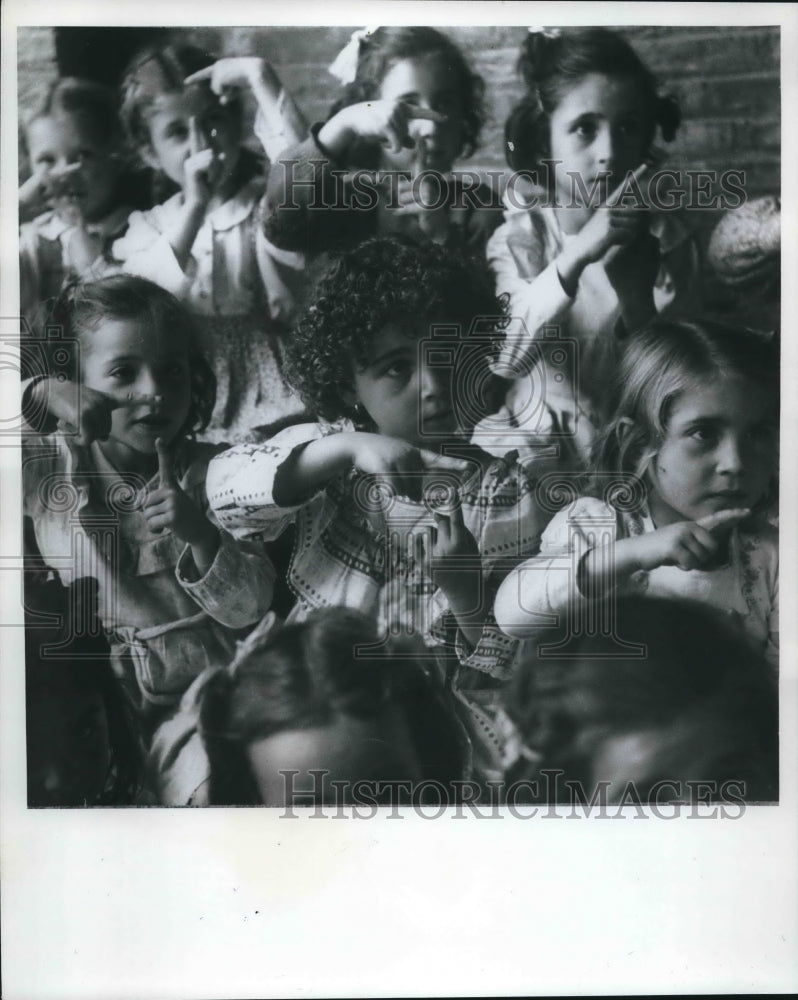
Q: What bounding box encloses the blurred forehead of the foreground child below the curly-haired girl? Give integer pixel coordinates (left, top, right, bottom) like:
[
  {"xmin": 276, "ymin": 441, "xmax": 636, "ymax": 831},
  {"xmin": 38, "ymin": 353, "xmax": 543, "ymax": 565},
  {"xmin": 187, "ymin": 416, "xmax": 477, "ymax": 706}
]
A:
[{"xmin": 247, "ymin": 716, "xmax": 421, "ymax": 806}]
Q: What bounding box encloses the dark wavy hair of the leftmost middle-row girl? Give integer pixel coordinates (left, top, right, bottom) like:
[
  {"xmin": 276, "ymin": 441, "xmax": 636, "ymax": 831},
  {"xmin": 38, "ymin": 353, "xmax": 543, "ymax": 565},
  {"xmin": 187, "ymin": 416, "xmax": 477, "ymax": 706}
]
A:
[{"xmin": 48, "ymin": 274, "xmax": 216, "ymax": 436}]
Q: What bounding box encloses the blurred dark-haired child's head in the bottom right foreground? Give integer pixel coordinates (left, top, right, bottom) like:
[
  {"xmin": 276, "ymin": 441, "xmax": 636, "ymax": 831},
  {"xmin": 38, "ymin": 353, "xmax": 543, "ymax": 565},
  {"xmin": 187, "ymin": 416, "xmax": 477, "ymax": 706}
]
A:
[{"xmin": 506, "ymin": 597, "xmax": 778, "ymax": 800}]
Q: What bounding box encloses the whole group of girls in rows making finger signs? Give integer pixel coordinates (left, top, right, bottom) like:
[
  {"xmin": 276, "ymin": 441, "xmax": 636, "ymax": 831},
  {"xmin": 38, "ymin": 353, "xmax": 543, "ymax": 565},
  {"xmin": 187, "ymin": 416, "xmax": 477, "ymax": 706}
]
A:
[{"xmin": 20, "ymin": 27, "xmax": 779, "ymax": 805}]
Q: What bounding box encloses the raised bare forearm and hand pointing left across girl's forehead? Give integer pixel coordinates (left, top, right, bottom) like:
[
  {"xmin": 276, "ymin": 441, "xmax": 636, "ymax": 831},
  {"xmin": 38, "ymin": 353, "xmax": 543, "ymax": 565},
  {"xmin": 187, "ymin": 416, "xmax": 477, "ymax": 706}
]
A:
[{"xmin": 184, "ymin": 56, "xmax": 308, "ymax": 163}]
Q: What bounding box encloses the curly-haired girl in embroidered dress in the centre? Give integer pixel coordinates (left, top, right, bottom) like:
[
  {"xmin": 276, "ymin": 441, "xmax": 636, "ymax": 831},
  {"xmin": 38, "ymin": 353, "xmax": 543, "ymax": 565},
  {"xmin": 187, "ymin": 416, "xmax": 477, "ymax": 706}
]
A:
[{"xmin": 208, "ymin": 237, "xmax": 556, "ymax": 784}]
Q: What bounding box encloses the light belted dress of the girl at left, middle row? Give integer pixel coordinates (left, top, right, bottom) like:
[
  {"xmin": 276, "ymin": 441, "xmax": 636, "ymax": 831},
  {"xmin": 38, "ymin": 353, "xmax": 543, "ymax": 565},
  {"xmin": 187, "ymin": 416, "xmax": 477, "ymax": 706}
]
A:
[{"xmin": 23, "ymin": 434, "xmax": 274, "ymax": 735}]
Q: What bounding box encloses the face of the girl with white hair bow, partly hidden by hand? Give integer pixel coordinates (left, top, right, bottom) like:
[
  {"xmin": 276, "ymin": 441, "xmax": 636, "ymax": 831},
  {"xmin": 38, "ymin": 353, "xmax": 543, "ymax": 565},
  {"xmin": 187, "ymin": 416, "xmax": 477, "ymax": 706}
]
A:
[{"xmin": 379, "ymin": 52, "xmax": 464, "ymax": 173}]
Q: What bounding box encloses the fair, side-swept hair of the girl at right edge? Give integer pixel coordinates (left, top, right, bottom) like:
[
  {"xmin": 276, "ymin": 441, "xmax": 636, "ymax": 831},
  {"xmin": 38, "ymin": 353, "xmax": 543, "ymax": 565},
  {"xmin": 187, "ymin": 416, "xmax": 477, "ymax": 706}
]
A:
[{"xmin": 593, "ymin": 319, "xmax": 779, "ymax": 475}]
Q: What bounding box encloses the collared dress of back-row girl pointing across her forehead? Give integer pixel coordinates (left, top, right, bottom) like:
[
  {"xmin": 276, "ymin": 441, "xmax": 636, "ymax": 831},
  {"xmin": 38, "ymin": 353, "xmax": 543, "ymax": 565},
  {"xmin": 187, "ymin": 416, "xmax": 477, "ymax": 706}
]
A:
[{"xmin": 113, "ymin": 177, "xmax": 303, "ymax": 442}]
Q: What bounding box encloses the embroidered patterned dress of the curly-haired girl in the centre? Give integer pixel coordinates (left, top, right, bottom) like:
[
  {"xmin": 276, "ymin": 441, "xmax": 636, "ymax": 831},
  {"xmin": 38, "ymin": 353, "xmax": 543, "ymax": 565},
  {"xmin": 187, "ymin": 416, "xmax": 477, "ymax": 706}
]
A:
[{"xmin": 208, "ymin": 422, "xmax": 556, "ymax": 777}]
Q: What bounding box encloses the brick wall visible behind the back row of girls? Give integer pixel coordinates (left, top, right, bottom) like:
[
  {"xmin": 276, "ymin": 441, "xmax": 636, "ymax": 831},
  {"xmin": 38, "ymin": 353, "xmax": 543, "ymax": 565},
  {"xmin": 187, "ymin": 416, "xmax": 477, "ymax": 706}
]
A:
[{"xmin": 18, "ymin": 27, "xmax": 781, "ymax": 203}]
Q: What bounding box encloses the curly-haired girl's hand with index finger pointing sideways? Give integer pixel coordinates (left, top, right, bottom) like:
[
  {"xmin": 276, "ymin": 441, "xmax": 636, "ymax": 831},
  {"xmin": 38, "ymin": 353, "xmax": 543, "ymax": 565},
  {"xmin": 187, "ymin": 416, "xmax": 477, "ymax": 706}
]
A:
[{"xmin": 346, "ymin": 431, "xmax": 468, "ymax": 500}]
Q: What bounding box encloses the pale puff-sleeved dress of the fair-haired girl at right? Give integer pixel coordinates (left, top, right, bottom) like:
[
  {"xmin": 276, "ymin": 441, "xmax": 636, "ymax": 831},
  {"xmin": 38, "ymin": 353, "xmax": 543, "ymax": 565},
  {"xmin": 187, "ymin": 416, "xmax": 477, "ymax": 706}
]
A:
[{"xmin": 506, "ymin": 497, "xmax": 779, "ymax": 670}]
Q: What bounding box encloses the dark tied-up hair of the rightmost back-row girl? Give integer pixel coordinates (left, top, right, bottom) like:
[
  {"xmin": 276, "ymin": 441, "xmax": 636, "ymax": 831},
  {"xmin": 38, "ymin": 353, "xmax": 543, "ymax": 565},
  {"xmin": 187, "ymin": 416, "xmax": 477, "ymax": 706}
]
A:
[{"xmin": 504, "ymin": 28, "xmax": 681, "ymax": 171}]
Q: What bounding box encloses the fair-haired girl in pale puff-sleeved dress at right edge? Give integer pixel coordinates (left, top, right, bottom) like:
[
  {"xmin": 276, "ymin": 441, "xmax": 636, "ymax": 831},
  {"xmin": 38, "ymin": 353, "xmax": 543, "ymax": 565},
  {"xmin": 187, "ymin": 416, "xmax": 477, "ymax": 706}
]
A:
[{"xmin": 495, "ymin": 320, "xmax": 779, "ymax": 668}]
